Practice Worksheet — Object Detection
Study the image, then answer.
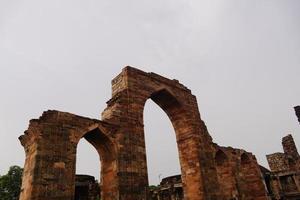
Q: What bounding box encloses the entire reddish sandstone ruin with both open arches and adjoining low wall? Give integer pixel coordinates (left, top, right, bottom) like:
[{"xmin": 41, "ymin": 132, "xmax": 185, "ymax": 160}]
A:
[{"xmin": 20, "ymin": 67, "xmax": 268, "ymax": 200}]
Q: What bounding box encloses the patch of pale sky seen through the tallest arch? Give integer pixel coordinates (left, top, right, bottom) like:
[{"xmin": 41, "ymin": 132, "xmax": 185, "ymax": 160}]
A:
[{"xmin": 144, "ymin": 99, "xmax": 181, "ymax": 186}]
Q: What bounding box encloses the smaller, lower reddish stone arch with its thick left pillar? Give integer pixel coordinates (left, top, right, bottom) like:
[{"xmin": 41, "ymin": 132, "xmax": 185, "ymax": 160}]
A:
[{"xmin": 20, "ymin": 111, "xmax": 118, "ymax": 200}]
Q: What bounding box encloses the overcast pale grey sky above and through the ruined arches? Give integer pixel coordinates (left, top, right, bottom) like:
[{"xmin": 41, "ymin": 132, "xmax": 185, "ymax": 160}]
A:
[{"xmin": 0, "ymin": 0, "xmax": 300, "ymax": 184}]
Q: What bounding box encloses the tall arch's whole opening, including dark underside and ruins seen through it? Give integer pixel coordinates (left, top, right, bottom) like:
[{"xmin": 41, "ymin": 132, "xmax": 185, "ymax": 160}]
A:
[{"xmin": 143, "ymin": 90, "xmax": 188, "ymax": 199}]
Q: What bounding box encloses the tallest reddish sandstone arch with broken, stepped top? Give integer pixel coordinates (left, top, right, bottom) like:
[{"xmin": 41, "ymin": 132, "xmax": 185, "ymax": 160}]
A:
[{"xmin": 102, "ymin": 67, "xmax": 219, "ymax": 200}]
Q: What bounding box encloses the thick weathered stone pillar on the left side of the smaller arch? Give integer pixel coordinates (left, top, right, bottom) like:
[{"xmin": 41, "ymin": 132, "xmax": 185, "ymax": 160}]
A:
[{"xmin": 20, "ymin": 120, "xmax": 76, "ymax": 200}]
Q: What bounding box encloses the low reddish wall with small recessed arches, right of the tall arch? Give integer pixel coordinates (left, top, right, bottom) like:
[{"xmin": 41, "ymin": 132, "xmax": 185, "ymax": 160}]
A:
[{"xmin": 215, "ymin": 145, "xmax": 268, "ymax": 200}]
